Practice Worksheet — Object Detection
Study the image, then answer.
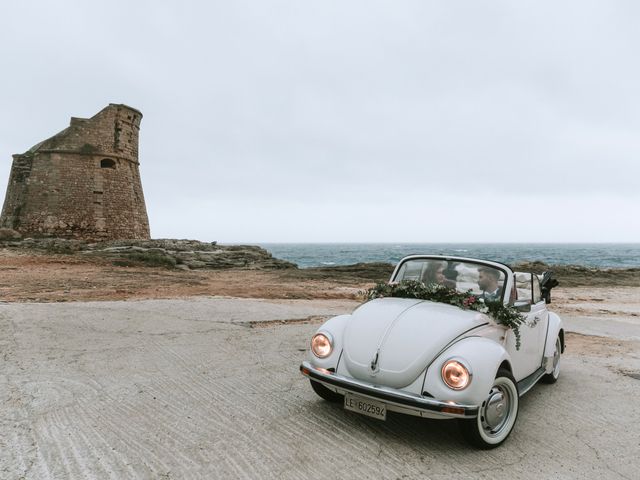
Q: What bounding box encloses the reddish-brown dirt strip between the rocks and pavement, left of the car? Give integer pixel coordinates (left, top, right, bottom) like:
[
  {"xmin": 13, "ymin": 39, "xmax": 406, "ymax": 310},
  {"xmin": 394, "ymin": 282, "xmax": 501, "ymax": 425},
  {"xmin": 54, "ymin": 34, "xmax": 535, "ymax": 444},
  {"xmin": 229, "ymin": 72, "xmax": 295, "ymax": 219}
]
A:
[{"xmin": 0, "ymin": 249, "xmax": 364, "ymax": 302}]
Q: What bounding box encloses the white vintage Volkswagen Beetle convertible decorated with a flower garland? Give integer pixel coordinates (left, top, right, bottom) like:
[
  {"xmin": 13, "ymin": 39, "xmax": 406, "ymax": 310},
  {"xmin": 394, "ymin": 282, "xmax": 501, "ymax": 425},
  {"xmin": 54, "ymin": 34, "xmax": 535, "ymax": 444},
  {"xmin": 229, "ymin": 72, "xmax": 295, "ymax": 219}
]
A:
[{"xmin": 300, "ymin": 255, "xmax": 564, "ymax": 448}]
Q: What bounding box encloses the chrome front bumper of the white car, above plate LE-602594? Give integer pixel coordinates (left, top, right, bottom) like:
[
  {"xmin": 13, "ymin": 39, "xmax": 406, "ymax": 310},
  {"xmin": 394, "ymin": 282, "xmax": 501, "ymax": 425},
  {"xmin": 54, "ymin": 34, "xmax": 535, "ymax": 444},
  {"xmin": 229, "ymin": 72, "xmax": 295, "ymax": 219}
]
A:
[{"xmin": 300, "ymin": 361, "xmax": 478, "ymax": 418}]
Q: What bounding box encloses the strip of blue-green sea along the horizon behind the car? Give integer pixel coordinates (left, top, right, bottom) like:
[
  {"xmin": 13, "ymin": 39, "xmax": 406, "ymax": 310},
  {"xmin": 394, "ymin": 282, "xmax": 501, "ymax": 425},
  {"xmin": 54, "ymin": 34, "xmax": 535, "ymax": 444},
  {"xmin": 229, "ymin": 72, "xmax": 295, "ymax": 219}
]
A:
[{"xmin": 260, "ymin": 243, "xmax": 640, "ymax": 268}]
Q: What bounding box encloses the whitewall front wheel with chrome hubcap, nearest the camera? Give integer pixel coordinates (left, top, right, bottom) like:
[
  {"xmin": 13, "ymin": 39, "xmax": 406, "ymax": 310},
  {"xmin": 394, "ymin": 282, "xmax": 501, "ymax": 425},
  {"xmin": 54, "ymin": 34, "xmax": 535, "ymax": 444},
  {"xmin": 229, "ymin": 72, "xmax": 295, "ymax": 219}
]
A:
[{"xmin": 460, "ymin": 368, "xmax": 519, "ymax": 449}]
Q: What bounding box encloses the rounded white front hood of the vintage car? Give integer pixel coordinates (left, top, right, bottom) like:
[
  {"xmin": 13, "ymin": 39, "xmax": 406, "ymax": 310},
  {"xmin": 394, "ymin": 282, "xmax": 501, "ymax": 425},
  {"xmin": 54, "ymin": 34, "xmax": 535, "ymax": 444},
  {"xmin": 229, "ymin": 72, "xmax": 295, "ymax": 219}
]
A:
[{"xmin": 343, "ymin": 298, "xmax": 489, "ymax": 388}]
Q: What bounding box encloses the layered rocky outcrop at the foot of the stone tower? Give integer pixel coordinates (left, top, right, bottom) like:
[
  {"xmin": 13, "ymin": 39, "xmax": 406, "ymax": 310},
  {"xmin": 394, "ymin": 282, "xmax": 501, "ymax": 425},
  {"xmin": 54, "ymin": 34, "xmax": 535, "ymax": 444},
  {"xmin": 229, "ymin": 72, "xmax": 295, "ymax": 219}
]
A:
[{"xmin": 0, "ymin": 238, "xmax": 297, "ymax": 270}]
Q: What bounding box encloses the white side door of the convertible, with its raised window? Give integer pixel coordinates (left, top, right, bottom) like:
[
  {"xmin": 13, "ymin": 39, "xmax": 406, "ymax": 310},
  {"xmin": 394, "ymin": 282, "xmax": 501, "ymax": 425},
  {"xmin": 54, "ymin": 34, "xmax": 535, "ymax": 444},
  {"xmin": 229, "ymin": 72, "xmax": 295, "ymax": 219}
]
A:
[{"xmin": 507, "ymin": 273, "xmax": 548, "ymax": 381}]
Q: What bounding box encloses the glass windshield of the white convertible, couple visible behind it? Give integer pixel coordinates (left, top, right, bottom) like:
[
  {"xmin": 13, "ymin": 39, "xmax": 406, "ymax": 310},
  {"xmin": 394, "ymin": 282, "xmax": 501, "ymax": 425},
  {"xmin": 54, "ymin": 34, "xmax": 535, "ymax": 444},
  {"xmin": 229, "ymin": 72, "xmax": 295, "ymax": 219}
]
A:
[{"xmin": 393, "ymin": 258, "xmax": 505, "ymax": 300}]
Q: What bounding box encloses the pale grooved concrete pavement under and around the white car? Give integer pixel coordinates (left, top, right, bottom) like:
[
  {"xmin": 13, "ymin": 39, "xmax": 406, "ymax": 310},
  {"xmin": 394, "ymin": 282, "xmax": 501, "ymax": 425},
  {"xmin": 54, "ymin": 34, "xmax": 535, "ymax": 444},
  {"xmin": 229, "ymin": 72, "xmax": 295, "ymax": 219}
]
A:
[{"xmin": 0, "ymin": 299, "xmax": 640, "ymax": 480}]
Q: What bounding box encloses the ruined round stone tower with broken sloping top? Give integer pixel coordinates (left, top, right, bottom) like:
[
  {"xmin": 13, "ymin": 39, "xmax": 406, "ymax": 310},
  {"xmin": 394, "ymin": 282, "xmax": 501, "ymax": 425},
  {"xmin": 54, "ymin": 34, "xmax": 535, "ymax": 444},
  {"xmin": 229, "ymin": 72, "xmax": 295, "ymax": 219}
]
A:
[{"xmin": 0, "ymin": 104, "xmax": 149, "ymax": 240}]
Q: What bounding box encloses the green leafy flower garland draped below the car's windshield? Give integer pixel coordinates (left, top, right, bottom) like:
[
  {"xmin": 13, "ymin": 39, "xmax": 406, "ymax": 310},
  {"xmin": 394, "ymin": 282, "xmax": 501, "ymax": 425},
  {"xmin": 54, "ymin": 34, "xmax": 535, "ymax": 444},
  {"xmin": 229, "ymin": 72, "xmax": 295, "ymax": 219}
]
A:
[{"xmin": 363, "ymin": 280, "xmax": 526, "ymax": 350}]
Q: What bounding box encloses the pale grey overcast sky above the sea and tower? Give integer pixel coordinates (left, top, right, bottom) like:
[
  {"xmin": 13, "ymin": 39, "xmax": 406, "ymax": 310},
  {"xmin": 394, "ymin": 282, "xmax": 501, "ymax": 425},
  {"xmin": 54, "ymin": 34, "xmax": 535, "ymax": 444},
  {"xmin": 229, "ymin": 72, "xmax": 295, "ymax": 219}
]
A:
[{"xmin": 0, "ymin": 0, "xmax": 640, "ymax": 243}]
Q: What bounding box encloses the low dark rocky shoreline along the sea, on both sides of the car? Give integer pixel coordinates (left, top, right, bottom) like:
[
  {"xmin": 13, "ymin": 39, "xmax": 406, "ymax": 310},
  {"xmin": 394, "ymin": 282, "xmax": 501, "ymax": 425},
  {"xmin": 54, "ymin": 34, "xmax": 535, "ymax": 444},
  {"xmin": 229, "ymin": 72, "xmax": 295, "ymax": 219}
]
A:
[{"xmin": 0, "ymin": 232, "xmax": 640, "ymax": 287}]
